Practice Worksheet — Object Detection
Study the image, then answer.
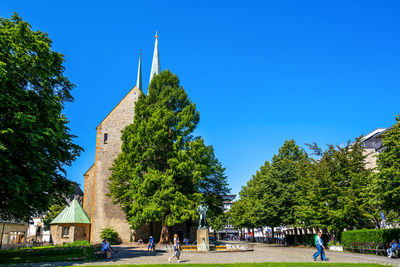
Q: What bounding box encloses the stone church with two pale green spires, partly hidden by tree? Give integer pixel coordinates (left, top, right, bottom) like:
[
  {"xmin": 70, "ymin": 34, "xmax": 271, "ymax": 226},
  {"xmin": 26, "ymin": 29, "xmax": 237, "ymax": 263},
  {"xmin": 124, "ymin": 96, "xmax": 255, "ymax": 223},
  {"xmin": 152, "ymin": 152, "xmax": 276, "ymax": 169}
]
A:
[{"xmin": 83, "ymin": 34, "xmax": 194, "ymax": 243}]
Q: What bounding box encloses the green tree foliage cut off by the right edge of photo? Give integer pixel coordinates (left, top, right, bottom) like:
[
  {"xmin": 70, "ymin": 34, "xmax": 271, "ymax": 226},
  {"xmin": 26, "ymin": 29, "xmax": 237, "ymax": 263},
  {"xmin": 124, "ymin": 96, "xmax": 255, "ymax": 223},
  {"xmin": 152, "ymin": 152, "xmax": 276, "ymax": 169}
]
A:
[{"xmin": 374, "ymin": 115, "xmax": 400, "ymax": 216}]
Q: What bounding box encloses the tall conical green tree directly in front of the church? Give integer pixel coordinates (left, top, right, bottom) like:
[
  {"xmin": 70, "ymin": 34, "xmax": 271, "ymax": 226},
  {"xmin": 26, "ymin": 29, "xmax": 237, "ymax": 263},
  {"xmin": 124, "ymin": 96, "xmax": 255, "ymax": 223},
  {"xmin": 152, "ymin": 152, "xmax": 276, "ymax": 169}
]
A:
[{"xmin": 110, "ymin": 71, "xmax": 228, "ymax": 242}]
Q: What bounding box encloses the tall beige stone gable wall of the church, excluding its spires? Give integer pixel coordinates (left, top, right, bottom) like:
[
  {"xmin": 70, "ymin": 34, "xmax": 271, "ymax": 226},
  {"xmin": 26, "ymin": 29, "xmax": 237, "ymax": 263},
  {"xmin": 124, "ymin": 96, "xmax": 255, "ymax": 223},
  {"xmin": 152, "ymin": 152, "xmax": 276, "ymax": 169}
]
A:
[{"xmin": 83, "ymin": 87, "xmax": 140, "ymax": 243}]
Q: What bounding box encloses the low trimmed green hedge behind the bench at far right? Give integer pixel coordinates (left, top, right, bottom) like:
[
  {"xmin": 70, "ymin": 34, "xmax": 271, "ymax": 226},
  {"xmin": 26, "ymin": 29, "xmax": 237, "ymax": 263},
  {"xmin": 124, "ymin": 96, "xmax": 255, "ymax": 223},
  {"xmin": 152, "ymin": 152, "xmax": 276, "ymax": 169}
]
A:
[{"xmin": 341, "ymin": 228, "xmax": 400, "ymax": 247}]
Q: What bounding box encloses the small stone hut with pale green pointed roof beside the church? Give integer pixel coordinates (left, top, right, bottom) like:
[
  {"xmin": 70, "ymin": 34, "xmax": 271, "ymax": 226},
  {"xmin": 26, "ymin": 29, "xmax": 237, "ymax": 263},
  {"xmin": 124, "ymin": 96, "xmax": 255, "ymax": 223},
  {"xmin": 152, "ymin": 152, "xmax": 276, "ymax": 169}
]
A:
[{"xmin": 50, "ymin": 199, "xmax": 90, "ymax": 245}]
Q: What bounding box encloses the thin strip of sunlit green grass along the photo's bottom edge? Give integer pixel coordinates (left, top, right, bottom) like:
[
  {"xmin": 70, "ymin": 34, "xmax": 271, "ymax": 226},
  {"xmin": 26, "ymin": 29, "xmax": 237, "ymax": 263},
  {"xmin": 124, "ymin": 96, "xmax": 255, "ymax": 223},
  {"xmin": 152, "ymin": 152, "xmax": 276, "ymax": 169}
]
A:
[{"xmin": 86, "ymin": 262, "xmax": 387, "ymax": 267}]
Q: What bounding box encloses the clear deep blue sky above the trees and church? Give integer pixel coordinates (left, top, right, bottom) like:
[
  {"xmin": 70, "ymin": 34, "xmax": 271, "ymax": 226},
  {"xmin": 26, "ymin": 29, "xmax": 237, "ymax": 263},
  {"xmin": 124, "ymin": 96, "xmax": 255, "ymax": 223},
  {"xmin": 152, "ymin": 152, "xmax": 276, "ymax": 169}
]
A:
[{"xmin": 0, "ymin": 0, "xmax": 400, "ymax": 197}]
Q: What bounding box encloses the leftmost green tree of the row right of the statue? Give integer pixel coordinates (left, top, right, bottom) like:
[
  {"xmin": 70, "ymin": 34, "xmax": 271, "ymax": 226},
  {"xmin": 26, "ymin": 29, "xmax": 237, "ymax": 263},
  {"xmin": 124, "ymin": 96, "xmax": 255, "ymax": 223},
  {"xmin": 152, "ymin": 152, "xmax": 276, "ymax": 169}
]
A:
[{"xmin": 231, "ymin": 140, "xmax": 308, "ymax": 234}]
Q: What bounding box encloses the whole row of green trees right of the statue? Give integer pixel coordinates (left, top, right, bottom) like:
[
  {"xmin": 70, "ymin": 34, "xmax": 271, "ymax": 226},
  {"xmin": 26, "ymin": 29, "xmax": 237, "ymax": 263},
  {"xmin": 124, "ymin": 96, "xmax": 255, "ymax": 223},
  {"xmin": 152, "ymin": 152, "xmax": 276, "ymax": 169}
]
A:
[{"xmin": 229, "ymin": 116, "xmax": 400, "ymax": 240}]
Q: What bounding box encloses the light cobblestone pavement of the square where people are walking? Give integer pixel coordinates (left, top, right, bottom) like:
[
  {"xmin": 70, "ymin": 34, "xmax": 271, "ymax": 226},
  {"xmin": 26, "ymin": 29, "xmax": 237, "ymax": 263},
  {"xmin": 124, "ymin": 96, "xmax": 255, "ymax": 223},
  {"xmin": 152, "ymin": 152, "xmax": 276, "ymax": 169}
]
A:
[{"xmin": 5, "ymin": 244, "xmax": 400, "ymax": 267}]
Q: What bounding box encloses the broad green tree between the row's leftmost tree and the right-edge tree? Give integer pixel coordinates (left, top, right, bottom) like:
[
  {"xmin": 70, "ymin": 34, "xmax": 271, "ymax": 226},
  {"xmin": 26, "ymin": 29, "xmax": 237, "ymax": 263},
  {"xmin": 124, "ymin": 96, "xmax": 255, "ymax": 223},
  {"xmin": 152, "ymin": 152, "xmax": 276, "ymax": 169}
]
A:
[{"xmin": 296, "ymin": 139, "xmax": 378, "ymax": 233}]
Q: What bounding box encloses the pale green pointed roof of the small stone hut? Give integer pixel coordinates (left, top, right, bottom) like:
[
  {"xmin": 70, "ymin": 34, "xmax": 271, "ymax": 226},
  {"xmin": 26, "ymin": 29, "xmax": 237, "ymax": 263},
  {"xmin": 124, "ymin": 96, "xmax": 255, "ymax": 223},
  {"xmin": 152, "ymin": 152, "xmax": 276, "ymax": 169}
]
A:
[{"xmin": 50, "ymin": 199, "xmax": 90, "ymax": 224}]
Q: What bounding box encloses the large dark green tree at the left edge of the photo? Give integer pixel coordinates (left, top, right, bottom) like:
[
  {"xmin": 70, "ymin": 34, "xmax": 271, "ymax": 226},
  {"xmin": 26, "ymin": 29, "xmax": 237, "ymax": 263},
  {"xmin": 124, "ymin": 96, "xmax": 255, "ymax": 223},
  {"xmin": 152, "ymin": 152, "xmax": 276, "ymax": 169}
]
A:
[{"xmin": 0, "ymin": 14, "xmax": 81, "ymax": 220}]
